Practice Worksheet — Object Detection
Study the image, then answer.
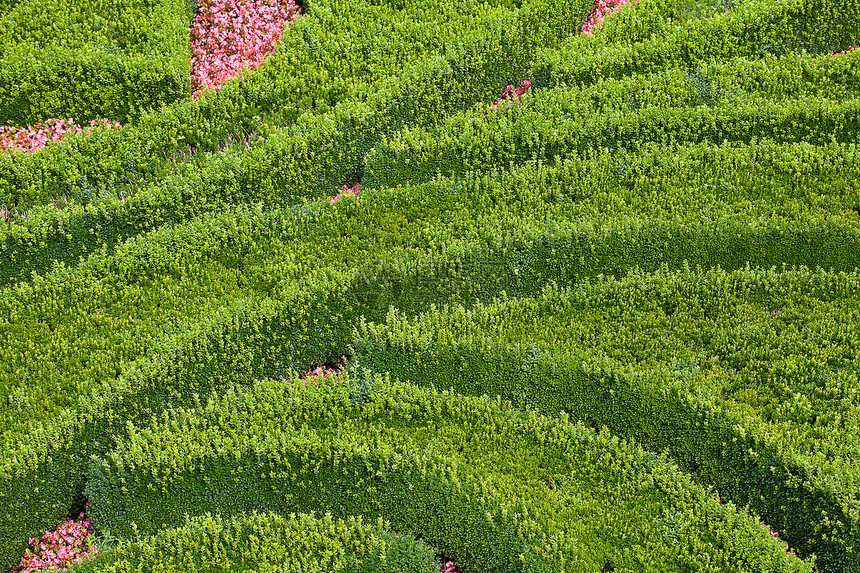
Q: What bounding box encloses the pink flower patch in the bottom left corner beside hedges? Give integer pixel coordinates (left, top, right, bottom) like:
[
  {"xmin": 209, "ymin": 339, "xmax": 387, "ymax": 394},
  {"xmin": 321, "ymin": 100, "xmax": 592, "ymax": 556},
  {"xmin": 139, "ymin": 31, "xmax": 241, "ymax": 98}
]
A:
[{"xmin": 19, "ymin": 513, "xmax": 98, "ymax": 573}]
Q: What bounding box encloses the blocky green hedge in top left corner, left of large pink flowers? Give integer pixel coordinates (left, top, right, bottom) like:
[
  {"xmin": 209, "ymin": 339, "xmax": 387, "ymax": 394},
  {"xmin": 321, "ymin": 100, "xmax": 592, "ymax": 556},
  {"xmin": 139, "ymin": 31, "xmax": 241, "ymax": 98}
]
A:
[{"xmin": 0, "ymin": 0, "xmax": 195, "ymax": 126}]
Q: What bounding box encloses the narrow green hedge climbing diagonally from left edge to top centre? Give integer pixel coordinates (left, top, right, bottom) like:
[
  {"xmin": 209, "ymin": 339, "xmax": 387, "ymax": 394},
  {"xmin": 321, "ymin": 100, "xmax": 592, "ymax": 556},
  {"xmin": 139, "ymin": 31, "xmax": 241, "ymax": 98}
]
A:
[{"xmin": 0, "ymin": 1, "xmax": 592, "ymax": 292}]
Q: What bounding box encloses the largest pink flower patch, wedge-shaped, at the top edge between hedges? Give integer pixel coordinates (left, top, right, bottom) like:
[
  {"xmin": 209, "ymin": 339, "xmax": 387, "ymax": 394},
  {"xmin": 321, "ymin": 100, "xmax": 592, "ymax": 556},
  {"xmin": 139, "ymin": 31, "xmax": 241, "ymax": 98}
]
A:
[{"xmin": 191, "ymin": 0, "xmax": 299, "ymax": 97}]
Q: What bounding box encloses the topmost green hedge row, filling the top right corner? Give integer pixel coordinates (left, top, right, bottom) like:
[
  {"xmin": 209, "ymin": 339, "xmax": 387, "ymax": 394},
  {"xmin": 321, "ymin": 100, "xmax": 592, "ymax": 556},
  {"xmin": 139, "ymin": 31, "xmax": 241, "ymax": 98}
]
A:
[{"xmin": 532, "ymin": 0, "xmax": 860, "ymax": 88}]
